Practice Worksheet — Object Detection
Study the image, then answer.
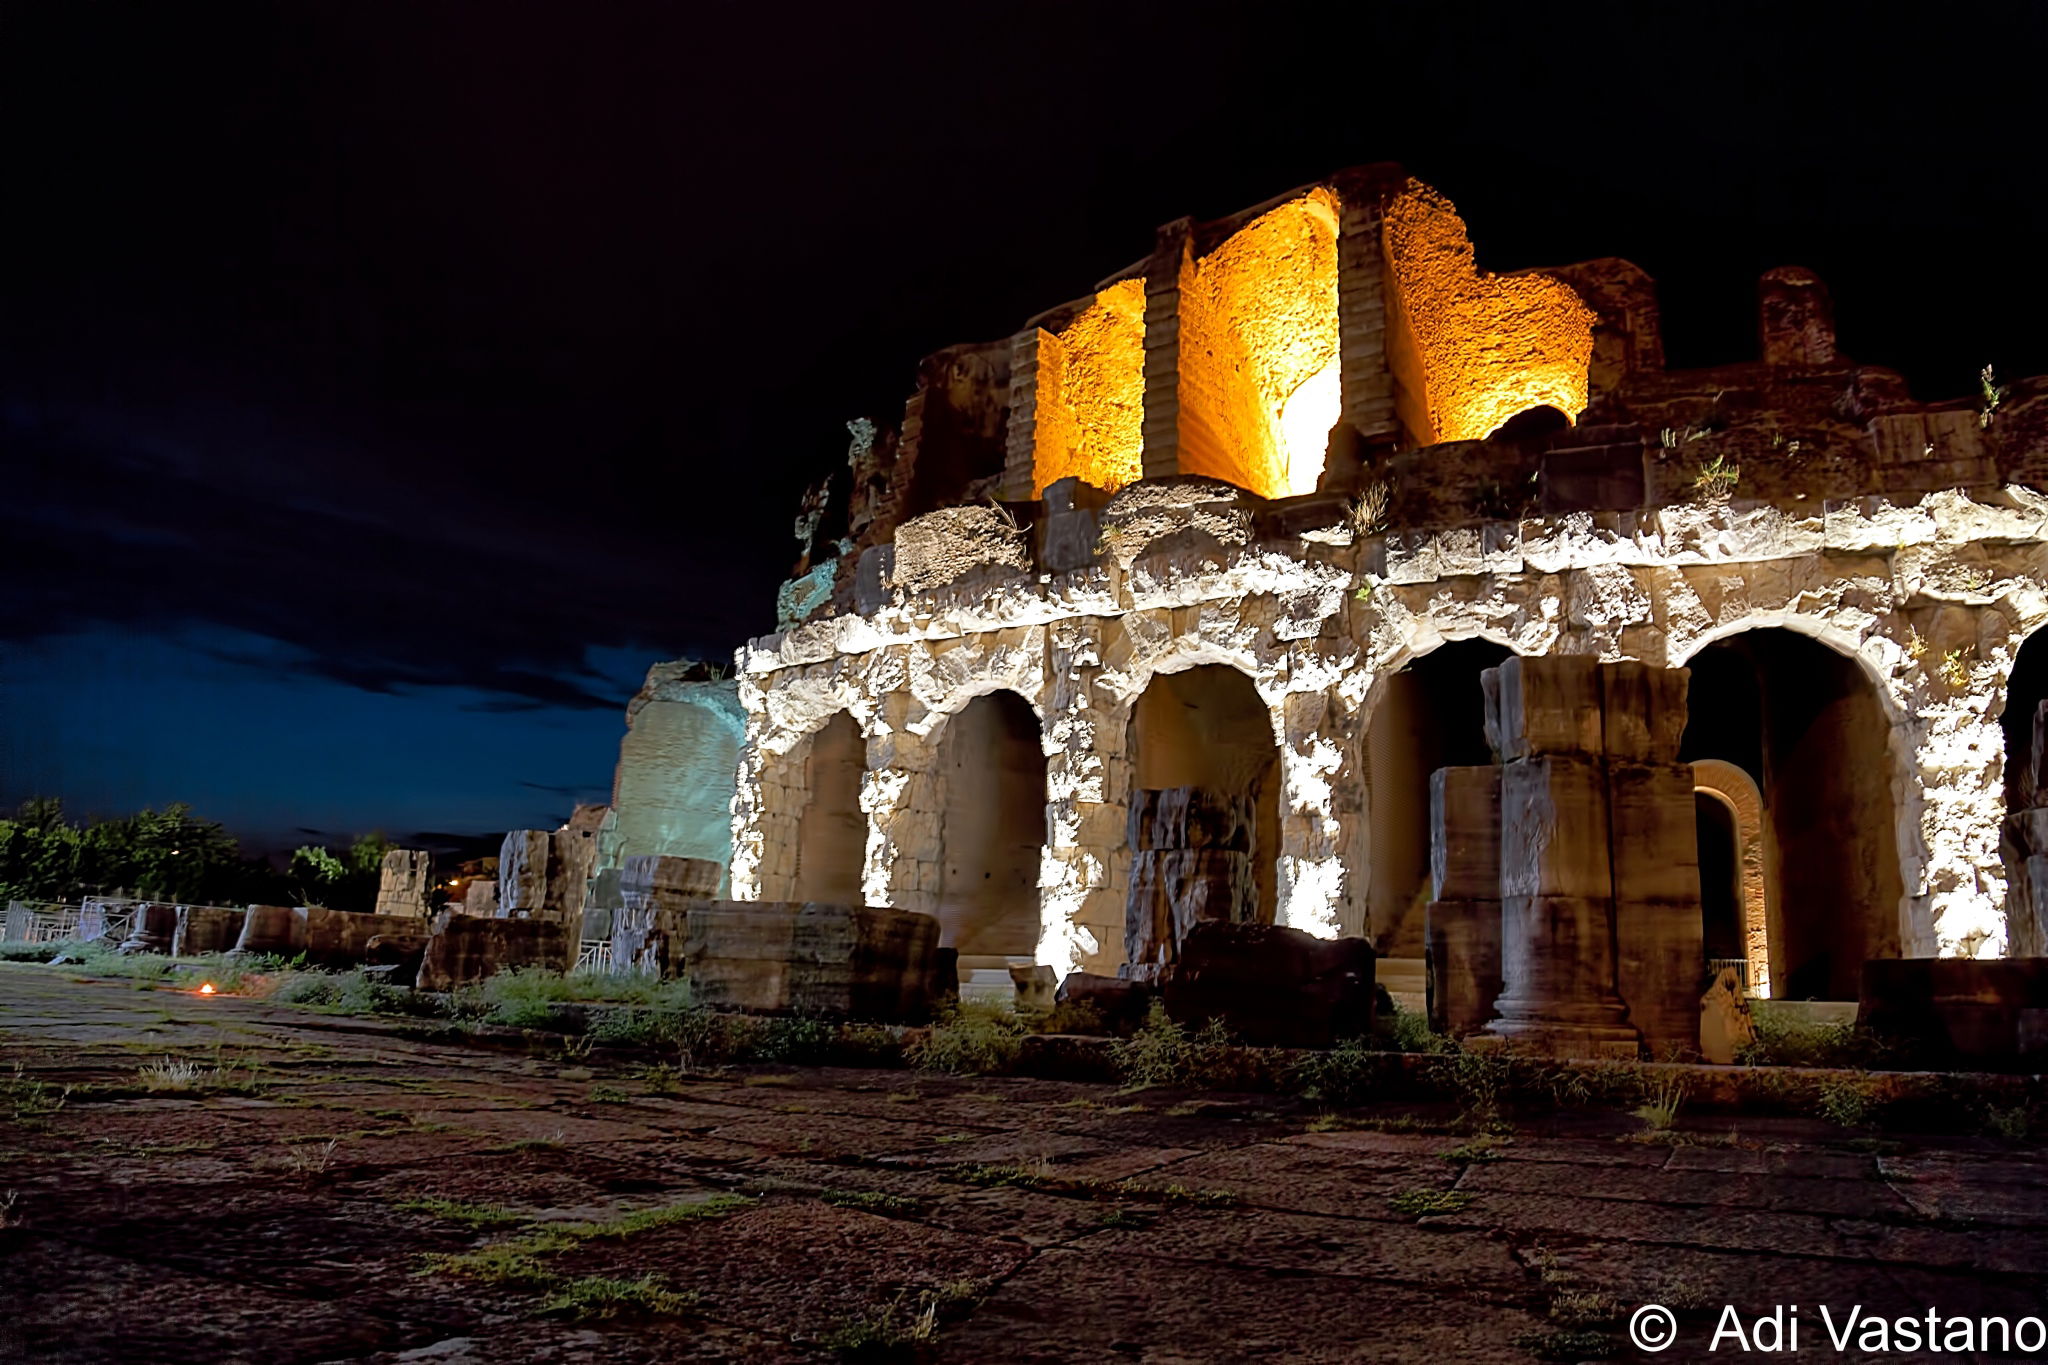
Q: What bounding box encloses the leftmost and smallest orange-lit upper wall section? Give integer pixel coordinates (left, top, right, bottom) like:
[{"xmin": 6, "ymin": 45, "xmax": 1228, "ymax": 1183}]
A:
[{"xmin": 1030, "ymin": 280, "xmax": 1145, "ymax": 497}]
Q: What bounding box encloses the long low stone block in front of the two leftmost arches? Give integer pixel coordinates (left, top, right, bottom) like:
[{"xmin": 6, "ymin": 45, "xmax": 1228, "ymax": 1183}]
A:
[{"xmin": 684, "ymin": 900, "xmax": 938, "ymax": 1021}]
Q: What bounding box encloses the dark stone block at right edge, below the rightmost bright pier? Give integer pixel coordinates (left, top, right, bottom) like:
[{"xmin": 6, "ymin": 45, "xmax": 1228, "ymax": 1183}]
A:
[{"xmin": 1855, "ymin": 958, "xmax": 2048, "ymax": 1070}]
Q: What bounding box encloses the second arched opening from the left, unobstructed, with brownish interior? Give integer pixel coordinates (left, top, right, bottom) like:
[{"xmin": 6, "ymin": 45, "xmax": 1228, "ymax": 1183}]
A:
[{"xmin": 938, "ymin": 692, "xmax": 1047, "ymax": 972}]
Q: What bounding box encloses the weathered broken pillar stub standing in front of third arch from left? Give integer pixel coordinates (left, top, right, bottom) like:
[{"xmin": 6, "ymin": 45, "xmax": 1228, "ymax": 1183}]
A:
[{"xmin": 1118, "ymin": 786, "xmax": 1257, "ymax": 980}]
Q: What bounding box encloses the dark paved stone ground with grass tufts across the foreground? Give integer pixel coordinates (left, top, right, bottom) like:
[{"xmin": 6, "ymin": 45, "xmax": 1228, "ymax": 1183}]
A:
[{"xmin": 0, "ymin": 966, "xmax": 2048, "ymax": 1365}]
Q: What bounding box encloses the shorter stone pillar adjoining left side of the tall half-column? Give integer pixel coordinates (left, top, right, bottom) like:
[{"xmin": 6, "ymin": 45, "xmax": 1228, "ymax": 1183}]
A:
[{"xmin": 1423, "ymin": 763, "xmax": 1501, "ymax": 1038}]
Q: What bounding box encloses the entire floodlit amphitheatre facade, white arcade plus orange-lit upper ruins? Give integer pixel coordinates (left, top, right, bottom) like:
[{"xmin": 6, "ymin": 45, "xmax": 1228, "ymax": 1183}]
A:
[{"xmin": 731, "ymin": 166, "xmax": 2048, "ymax": 999}]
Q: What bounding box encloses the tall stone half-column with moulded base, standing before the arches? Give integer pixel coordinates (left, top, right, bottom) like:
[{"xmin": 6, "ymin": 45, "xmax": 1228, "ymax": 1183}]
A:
[{"xmin": 1483, "ymin": 655, "xmax": 1638, "ymax": 1056}]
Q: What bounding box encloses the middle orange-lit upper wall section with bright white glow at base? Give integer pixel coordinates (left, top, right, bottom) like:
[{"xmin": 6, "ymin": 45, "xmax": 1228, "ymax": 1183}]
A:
[{"xmin": 1178, "ymin": 188, "xmax": 1339, "ymax": 497}]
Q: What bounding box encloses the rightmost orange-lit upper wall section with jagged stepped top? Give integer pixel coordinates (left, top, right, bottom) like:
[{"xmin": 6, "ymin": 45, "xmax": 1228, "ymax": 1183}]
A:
[{"xmin": 1384, "ymin": 180, "xmax": 1595, "ymax": 444}]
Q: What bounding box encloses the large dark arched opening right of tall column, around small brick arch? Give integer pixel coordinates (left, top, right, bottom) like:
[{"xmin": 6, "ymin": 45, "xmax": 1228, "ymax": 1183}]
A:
[{"xmin": 1679, "ymin": 628, "xmax": 1905, "ymax": 1001}]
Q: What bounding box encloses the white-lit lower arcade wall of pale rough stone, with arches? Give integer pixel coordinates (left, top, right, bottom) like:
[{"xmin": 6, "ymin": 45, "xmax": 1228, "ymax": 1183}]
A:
[{"xmin": 733, "ymin": 489, "xmax": 2048, "ymax": 970}]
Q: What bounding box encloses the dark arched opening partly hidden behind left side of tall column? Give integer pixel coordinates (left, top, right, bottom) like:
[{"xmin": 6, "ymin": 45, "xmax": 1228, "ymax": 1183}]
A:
[{"xmin": 1366, "ymin": 641, "xmax": 1513, "ymax": 958}]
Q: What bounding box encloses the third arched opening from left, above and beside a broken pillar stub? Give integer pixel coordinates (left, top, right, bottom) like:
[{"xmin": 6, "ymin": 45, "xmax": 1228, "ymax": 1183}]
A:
[{"xmin": 1130, "ymin": 663, "xmax": 1280, "ymax": 923}]
